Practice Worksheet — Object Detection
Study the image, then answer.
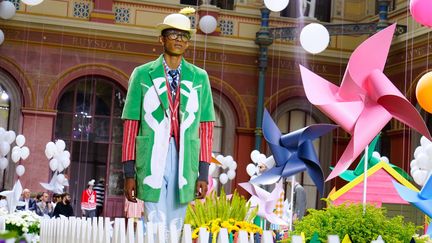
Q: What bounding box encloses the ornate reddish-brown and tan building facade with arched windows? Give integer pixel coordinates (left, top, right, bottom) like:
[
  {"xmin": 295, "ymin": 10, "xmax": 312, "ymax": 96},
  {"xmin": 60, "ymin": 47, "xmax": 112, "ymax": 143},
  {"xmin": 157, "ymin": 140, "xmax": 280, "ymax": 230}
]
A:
[{"xmin": 0, "ymin": 0, "xmax": 432, "ymax": 216}]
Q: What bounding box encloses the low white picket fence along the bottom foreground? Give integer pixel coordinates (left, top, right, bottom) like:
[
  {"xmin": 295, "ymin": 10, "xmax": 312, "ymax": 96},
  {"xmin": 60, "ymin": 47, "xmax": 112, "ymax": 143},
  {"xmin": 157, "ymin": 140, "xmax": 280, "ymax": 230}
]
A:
[{"xmin": 40, "ymin": 217, "xmax": 273, "ymax": 243}]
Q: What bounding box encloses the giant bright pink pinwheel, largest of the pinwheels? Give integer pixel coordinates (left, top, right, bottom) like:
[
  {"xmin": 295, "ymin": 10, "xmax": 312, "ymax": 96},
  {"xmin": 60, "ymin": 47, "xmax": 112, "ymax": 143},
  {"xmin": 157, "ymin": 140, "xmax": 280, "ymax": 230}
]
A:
[{"xmin": 300, "ymin": 25, "xmax": 432, "ymax": 180}]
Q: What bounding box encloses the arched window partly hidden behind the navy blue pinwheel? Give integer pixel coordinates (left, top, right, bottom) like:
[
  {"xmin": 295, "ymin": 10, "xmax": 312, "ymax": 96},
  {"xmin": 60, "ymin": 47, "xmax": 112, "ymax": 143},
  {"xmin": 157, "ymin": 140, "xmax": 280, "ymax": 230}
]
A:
[{"xmin": 273, "ymin": 99, "xmax": 331, "ymax": 208}]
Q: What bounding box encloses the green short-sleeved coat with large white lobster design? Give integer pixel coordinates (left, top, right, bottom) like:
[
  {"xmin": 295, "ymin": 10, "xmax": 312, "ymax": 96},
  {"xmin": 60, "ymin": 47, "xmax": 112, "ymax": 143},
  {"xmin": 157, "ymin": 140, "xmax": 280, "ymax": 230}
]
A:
[{"xmin": 122, "ymin": 55, "xmax": 215, "ymax": 203}]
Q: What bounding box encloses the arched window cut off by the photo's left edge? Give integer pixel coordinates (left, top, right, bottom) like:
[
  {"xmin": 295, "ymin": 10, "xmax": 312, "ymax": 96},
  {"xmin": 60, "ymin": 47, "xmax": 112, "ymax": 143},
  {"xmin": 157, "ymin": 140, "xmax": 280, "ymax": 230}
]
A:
[{"xmin": 0, "ymin": 68, "xmax": 22, "ymax": 191}]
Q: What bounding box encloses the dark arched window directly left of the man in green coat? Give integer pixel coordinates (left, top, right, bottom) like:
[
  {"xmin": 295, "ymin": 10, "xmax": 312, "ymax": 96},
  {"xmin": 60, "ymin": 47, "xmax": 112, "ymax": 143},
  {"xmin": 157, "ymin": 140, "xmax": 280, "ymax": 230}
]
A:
[{"xmin": 54, "ymin": 76, "xmax": 125, "ymax": 216}]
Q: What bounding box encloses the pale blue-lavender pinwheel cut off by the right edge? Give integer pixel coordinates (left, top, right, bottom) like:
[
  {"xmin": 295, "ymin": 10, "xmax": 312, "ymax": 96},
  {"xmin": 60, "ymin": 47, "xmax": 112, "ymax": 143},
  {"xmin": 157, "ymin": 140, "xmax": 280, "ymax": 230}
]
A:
[{"xmin": 393, "ymin": 176, "xmax": 432, "ymax": 237}]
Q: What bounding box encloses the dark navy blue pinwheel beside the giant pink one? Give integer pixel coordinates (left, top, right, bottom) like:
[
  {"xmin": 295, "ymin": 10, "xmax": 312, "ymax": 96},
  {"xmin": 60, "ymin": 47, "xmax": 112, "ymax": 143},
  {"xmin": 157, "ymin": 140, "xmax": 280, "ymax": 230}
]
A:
[{"xmin": 251, "ymin": 110, "xmax": 338, "ymax": 195}]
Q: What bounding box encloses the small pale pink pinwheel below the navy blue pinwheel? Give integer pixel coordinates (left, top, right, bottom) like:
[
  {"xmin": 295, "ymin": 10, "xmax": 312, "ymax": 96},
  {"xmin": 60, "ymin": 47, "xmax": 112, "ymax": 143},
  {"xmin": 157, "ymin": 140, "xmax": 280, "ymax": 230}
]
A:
[{"xmin": 239, "ymin": 180, "xmax": 288, "ymax": 225}]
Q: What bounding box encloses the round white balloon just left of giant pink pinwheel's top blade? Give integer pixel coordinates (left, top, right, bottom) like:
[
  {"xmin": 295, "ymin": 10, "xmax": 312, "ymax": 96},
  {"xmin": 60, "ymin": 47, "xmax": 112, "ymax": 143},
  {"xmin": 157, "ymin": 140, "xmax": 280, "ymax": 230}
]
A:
[{"xmin": 300, "ymin": 23, "xmax": 330, "ymax": 54}]
